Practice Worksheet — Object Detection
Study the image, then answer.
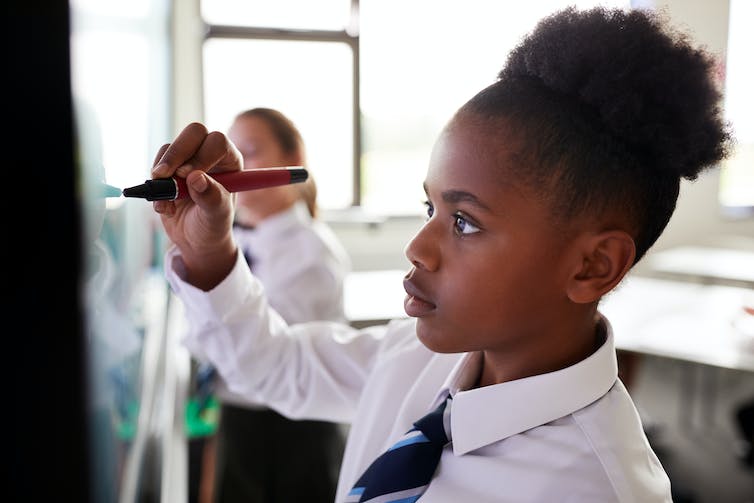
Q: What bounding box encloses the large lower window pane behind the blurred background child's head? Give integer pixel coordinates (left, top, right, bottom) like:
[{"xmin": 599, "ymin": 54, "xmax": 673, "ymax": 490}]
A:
[{"xmin": 204, "ymin": 39, "xmax": 353, "ymax": 209}]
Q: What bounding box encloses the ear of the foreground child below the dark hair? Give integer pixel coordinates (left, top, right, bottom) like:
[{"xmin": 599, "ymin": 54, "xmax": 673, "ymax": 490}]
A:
[{"xmin": 566, "ymin": 230, "xmax": 636, "ymax": 304}]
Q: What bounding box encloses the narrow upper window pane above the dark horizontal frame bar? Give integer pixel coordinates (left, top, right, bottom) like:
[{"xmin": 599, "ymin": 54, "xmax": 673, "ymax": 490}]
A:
[{"xmin": 201, "ymin": 0, "xmax": 351, "ymax": 30}]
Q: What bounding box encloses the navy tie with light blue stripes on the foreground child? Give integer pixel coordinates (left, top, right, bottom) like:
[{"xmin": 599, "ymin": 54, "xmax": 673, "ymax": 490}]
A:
[{"xmin": 345, "ymin": 397, "xmax": 451, "ymax": 503}]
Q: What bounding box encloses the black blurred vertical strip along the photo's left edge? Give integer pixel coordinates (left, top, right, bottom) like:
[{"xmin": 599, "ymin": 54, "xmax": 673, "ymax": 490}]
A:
[{"xmin": 0, "ymin": 0, "xmax": 86, "ymax": 502}]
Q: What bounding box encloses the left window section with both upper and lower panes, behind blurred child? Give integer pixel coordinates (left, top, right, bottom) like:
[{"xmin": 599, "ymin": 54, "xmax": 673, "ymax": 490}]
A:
[{"xmin": 201, "ymin": 0, "xmax": 359, "ymax": 209}]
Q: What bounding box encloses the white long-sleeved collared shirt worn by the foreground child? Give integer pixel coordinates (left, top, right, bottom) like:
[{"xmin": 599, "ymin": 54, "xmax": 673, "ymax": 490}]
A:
[{"xmin": 165, "ymin": 249, "xmax": 671, "ymax": 503}]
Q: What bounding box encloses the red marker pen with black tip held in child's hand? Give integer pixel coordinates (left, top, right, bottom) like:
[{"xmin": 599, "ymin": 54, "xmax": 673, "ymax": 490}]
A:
[{"xmin": 123, "ymin": 166, "xmax": 309, "ymax": 201}]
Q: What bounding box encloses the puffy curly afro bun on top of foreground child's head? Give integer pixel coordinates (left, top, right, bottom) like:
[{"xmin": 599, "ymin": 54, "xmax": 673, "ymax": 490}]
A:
[{"xmin": 498, "ymin": 7, "xmax": 730, "ymax": 179}]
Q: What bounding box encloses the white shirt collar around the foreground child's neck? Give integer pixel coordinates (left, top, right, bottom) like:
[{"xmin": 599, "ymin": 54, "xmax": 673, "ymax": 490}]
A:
[{"xmin": 440, "ymin": 315, "xmax": 618, "ymax": 456}]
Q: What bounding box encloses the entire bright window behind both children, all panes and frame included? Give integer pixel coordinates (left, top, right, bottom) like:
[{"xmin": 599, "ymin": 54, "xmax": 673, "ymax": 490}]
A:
[{"xmin": 202, "ymin": 0, "xmax": 629, "ymax": 215}]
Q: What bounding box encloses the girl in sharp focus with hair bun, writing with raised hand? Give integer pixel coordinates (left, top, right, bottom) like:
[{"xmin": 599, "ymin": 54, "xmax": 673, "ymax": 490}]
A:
[{"xmin": 153, "ymin": 8, "xmax": 729, "ymax": 502}]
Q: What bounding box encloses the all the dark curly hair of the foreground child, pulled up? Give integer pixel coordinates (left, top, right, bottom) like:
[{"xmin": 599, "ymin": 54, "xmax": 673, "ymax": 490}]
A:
[{"xmin": 461, "ymin": 7, "xmax": 731, "ymax": 262}]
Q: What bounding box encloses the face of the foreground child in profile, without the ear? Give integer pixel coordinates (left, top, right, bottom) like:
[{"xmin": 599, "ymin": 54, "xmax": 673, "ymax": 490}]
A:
[{"xmin": 404, "ymin": 112, "xmax": 572, "ymax": 356}]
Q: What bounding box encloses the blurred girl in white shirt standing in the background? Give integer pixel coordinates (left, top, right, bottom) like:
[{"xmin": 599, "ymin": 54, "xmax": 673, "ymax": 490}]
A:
[{"xmin": 200, "ymin": 107, "xmax": 350, "ymax": 503}]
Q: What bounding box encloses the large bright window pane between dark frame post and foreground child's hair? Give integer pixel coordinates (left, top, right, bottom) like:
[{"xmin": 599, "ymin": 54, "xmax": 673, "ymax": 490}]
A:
[{"xmin": 360, "ymin": 0, "xmax": 628, "ymax": 214}]
